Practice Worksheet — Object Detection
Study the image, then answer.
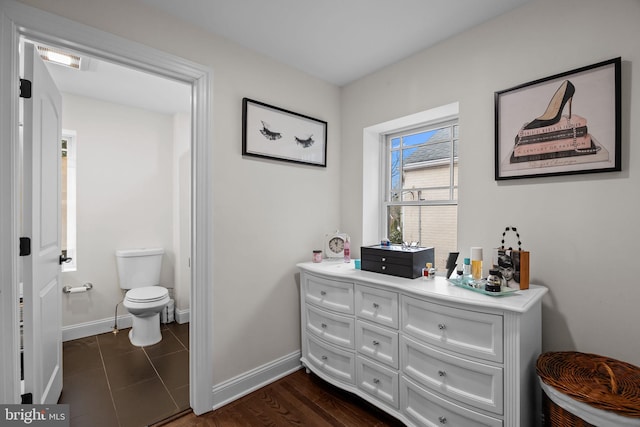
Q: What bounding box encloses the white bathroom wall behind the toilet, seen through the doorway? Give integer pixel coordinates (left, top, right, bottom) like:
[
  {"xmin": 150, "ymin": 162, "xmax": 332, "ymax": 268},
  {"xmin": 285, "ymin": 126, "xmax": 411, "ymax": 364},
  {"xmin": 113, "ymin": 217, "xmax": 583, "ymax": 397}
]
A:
[{"xmin": 62, "ymin": 94, "xmax": 175, "ymax": 326}]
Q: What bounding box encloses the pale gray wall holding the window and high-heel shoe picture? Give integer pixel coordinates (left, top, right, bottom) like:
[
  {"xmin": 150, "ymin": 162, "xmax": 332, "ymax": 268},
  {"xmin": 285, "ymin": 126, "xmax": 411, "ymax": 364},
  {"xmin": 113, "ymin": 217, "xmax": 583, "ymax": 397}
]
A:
[{"xmin": 340, "ymin": 0, "xmax": 640, "ymax": 365}]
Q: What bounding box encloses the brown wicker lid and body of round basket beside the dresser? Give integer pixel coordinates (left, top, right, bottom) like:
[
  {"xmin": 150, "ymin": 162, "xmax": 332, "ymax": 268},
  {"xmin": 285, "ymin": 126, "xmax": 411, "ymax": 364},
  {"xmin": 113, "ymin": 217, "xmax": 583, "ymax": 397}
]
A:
[{"xmin": 536, "ymin": 351, "xmax": 640, "ymax": 426}]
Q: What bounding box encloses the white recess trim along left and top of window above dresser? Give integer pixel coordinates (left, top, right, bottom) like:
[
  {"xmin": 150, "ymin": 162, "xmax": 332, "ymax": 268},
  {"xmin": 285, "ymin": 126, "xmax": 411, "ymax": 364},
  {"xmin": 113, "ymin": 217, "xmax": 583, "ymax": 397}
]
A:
[{"xmin": 362, "ymin": 102, "xmax": 459, "ymax": 246}]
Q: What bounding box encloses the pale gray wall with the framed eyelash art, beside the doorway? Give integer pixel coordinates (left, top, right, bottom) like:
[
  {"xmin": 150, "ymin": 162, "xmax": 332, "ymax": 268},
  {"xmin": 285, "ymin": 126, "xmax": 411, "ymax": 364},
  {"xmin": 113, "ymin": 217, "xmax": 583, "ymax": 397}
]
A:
[{"xmin": 20, "ymin": 0, "xmax": 341, "ymax": 383}]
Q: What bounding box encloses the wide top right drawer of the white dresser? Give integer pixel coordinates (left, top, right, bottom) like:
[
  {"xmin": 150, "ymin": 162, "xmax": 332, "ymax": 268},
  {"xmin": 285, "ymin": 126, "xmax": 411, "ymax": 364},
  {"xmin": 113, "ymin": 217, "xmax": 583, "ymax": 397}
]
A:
[{"xmin": 401, "ymin": 295, "xmax": 503, "ymax": 362}]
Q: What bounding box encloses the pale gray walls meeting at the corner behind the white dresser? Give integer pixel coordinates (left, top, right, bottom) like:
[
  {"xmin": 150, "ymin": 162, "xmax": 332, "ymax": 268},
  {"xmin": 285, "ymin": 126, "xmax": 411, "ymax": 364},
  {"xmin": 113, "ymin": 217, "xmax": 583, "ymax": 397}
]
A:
[{"xmin": 26, "ymin": 0, "xmax": 640, "ymax": 383}]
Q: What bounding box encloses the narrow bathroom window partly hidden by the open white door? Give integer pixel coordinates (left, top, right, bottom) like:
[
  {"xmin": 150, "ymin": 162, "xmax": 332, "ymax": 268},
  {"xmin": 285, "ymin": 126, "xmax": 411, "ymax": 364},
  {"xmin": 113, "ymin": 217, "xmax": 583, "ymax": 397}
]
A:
[{"xmin": 61, "ymin": 130, "xmax": 77, "ymax": 272}]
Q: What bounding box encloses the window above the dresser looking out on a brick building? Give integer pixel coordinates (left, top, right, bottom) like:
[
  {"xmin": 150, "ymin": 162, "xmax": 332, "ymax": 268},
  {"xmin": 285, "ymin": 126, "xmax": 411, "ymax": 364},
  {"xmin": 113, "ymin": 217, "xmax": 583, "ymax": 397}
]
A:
[{"xmin": 382, "ymin": 119, "xmax": 459, "ymax": 270}]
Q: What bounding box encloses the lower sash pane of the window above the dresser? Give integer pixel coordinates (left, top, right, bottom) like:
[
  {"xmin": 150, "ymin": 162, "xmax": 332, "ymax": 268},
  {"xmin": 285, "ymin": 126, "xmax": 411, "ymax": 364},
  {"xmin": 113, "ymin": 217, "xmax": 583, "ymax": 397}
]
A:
[{"xmin": 387, "ymin": 205, "xmax": 458, "ymax": 271}]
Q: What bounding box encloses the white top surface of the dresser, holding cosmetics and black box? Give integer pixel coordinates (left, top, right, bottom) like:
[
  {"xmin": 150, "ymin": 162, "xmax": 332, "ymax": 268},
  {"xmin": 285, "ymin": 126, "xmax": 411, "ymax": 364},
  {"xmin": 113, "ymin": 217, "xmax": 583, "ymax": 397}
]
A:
[{"xmin": 297, "ymin": 259, "xmax": 548, "ymax": 313}]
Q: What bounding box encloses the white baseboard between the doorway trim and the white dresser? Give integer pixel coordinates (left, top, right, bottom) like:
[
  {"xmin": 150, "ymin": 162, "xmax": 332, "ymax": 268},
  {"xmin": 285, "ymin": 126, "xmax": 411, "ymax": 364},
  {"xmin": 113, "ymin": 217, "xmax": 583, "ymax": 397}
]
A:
[{"xmin": 213, "ymin": 351, "xmax": 302, "ymax": 410}]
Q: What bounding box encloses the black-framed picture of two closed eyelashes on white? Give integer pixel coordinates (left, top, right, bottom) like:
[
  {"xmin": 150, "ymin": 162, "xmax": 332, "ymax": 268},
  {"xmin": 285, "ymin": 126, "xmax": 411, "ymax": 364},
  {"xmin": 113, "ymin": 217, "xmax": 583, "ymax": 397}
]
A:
[{"xmin": 242, "ymin": 98, "xmax": 327, "ymax": 167}]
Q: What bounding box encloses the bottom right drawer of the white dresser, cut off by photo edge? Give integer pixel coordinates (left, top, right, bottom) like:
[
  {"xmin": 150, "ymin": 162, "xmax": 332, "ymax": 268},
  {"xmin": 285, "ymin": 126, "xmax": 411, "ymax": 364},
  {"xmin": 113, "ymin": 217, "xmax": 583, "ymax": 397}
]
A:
[{"xmin": 400, "ymin": 376, "xmax": 502, "ymax": 427}]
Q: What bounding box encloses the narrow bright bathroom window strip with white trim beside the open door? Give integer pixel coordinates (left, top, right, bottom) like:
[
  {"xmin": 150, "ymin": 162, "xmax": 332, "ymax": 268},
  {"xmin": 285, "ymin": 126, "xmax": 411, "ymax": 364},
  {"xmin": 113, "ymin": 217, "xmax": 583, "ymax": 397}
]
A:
[{"xmin": 62, "ymin": 129, "xmax": 78, "ymax": 273}]
